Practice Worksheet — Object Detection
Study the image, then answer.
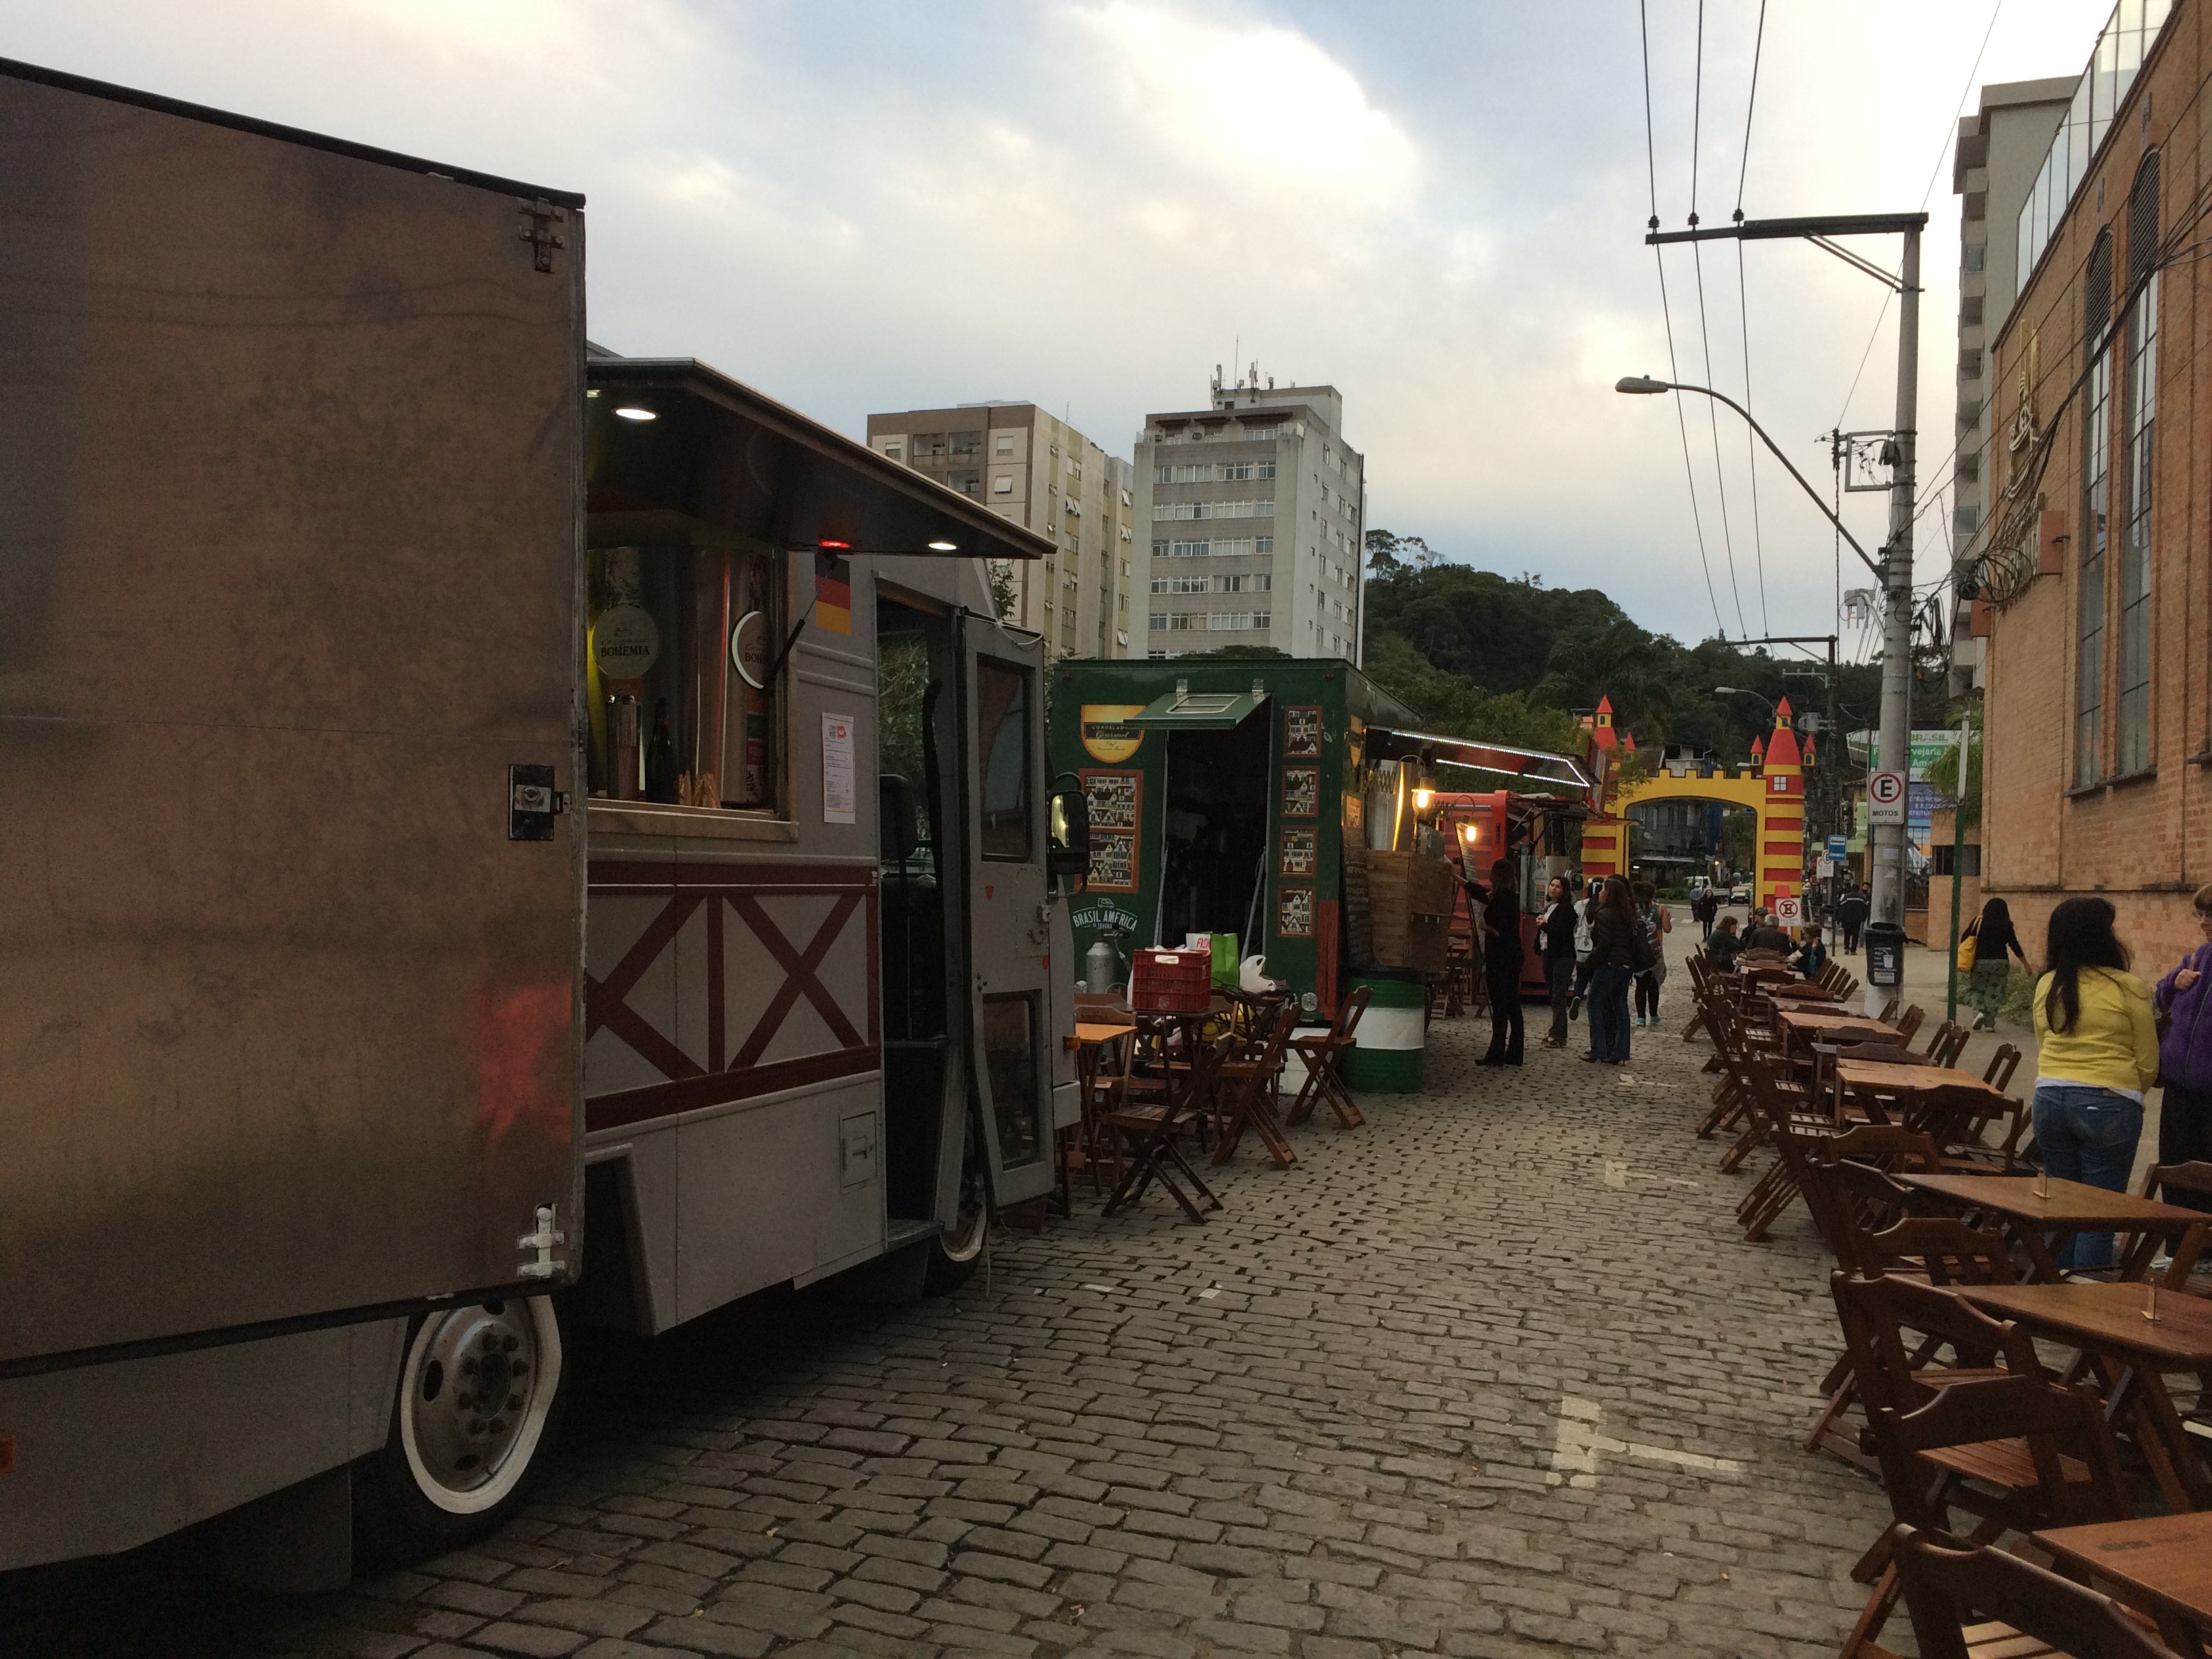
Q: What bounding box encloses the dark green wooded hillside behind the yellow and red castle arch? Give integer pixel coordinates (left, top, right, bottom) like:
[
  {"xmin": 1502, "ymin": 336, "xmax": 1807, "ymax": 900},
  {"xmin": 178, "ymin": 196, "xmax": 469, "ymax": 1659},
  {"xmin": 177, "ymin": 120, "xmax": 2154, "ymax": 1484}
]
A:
[{"xmin": 1365, "ymin": 531, "xmax": 1883, "ymax": 763}]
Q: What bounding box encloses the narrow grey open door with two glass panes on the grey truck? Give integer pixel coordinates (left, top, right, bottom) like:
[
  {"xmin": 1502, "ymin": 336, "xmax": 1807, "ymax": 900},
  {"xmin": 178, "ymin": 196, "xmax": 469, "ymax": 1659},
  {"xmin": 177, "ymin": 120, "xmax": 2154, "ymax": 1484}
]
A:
[{"xmin": 960, "ymin": 613, "xmax": 1066, "ymax": 1206}]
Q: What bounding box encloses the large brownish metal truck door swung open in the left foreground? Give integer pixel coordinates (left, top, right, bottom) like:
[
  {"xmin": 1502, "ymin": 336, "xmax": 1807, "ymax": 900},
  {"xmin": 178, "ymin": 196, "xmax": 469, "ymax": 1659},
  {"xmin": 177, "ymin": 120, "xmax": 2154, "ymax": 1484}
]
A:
[{"xmin": 0, "ymin": 64, "xmax": 584, "ymax": 1380}]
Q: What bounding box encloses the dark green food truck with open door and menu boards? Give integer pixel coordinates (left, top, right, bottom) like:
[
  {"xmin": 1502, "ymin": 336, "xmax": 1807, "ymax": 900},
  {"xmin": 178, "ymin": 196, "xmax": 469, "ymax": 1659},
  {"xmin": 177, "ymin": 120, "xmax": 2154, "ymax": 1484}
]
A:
[{"xmin": 1048, "ymin": 657, "xmax": 1589, "ymax": 1035}]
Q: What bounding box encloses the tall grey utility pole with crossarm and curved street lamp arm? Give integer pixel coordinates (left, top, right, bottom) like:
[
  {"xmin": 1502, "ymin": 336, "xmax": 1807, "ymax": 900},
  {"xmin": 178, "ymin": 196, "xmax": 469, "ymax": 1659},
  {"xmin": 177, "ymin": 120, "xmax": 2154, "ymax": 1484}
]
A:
[{"xmin": 1619, "ymin": 208, "xmax": 1929, "ymax": 1013}]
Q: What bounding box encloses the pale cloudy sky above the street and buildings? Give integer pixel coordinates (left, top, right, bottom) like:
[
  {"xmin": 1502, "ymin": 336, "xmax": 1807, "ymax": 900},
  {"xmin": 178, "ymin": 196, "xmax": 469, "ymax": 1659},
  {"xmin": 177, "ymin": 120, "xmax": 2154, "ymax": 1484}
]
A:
[{"xmin": 0, "ymin": 0, "xmax": 2110, "ymax": 659}]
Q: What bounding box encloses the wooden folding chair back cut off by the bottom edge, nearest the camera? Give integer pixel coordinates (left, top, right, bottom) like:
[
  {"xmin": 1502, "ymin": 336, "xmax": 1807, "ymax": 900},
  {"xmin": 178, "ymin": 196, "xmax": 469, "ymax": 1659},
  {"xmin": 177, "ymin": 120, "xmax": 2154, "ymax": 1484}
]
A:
[{"xmin": 1887, "ymin": 1524, "xmax": 2175, "ymax": 1659}]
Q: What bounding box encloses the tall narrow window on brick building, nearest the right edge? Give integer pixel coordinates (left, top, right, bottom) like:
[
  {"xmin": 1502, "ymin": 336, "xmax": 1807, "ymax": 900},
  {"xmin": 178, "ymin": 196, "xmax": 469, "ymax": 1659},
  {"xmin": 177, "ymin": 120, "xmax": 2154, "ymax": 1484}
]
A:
[{"xmin": 2112, "ymin": 150, "xmax": 2159, "ymax": 774}]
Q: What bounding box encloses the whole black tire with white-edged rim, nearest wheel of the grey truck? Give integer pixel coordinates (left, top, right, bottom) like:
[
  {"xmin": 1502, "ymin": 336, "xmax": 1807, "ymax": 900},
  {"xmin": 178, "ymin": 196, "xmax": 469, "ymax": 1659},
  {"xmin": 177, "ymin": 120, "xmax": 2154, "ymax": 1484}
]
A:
[{"xmin": 354, "ymin": 1296, "xmax": 567, "ymax": 1566}]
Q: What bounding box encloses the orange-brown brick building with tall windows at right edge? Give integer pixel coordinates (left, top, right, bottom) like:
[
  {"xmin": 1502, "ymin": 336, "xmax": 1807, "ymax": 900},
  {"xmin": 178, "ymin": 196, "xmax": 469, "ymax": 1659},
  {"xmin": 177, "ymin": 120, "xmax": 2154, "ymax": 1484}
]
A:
[{"xmin": 1962, "ymin": 0, "xmax": 2212, "ymax": 971}]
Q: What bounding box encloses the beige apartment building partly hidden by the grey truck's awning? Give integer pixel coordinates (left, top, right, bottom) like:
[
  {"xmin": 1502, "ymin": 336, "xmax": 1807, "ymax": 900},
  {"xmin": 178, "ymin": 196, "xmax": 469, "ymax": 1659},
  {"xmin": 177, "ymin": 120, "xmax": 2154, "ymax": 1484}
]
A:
[{"xmin": 867, "ymin": 403, "xmax": 1143, "ymax": 657}]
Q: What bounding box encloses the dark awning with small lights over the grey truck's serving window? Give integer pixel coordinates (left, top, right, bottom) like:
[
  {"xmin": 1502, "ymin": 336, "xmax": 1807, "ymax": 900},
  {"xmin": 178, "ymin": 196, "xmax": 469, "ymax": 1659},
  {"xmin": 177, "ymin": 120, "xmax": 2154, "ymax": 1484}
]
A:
[{"xmin": 584, "ymin": 356, "xmax": 1053, "ymax": 560}]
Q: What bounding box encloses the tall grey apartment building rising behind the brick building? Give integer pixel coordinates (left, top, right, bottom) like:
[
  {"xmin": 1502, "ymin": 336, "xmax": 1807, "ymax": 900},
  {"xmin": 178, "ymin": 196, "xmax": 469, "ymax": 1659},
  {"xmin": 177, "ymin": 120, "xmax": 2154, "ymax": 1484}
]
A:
[{"xmin": 1955, "ymin": 75, "xmax": 2077, "ymax": 697}]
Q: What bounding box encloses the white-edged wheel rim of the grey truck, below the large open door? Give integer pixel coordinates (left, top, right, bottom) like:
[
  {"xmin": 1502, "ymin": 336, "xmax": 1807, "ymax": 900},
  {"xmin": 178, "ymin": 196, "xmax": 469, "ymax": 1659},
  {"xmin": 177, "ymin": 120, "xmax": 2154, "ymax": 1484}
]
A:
[{"xmin": 401, "ymin": 1296, "xmax": 562, "ymax": 1515}]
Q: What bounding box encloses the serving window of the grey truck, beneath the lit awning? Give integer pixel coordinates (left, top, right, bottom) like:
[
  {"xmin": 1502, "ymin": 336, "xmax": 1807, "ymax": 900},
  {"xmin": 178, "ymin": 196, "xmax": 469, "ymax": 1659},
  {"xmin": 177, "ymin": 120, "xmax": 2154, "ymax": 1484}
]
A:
[{"xmin": 584, "ymin": 546, "xmax": 781, "ymax": 810}]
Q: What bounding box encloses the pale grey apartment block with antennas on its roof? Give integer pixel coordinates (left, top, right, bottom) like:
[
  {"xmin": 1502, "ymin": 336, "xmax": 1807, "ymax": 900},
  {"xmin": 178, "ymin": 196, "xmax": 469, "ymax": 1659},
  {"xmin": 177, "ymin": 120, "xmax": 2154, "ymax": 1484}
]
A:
[{"xmin": 1134, "ymin": 363, "xmax": 1367, "ymax": 663}]
